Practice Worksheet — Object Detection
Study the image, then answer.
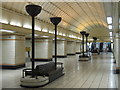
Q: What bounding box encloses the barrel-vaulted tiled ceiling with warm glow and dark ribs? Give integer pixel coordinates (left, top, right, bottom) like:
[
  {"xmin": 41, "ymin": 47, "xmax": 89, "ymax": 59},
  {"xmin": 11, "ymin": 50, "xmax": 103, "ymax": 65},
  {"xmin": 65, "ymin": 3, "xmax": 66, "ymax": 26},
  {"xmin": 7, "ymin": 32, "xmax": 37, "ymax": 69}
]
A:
[{"xmin": 2, "ymin": 0, "xmax": 119, "ymax": 40}]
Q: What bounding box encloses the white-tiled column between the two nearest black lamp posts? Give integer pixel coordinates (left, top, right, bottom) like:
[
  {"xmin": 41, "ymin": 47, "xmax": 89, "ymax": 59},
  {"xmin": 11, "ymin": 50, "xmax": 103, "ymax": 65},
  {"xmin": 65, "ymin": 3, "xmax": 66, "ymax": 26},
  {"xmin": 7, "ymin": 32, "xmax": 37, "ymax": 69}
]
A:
[{"xmin": 35, "ymin": 39, "xmax": 52, "ymax": 61}]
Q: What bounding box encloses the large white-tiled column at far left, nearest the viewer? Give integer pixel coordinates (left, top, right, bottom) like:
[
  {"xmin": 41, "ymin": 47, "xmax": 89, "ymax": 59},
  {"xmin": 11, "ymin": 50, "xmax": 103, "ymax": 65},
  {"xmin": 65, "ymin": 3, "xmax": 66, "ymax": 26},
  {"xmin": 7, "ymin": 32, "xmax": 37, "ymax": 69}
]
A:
[{"xmin": 0, "ymin": 35, "xmax": 25, "ymax": 69}]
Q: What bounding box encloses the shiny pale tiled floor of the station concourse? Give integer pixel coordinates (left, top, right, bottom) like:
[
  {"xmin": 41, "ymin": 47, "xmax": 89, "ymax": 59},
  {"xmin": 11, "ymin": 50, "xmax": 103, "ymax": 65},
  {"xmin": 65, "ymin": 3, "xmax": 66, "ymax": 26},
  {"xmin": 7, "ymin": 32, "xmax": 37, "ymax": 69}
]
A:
[{"xmin": 2, "ymin": 53, "xmax": 118, "ymax": 88}]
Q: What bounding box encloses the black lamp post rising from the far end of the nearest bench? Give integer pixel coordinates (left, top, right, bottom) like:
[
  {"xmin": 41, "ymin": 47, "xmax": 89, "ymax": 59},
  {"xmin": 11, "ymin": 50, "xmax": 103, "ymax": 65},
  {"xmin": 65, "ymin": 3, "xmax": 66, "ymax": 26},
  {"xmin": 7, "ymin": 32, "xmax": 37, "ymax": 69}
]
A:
[{"xmin": 50, "ymin": 17, "xmax": 61, "ymax": 69}]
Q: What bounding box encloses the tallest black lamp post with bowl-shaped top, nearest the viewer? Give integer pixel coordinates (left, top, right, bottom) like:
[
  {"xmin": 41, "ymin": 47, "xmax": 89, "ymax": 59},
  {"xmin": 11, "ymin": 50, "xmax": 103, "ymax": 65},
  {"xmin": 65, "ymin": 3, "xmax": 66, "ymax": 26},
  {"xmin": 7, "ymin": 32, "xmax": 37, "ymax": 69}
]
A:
[{"xmin": 26, "ymin": 5, "xmax": 42, "ymax": 77}]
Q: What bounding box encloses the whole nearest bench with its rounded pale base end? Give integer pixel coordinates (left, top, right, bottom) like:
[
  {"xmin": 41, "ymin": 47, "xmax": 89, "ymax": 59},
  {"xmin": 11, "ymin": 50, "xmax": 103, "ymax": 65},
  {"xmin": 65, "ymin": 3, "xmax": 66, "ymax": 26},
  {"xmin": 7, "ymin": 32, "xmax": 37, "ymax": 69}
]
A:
[{"xmin": 21, "ymin": 62, "xmax": 64, "ymax": 87}]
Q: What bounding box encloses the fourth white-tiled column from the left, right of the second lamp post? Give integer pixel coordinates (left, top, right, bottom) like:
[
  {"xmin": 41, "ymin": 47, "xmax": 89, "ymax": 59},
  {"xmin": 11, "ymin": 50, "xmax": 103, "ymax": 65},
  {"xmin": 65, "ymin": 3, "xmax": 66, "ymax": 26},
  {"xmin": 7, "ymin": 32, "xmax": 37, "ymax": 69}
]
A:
[{"xmin": 67, "ymin": 41, "xmax": 76, "ymax": 55}]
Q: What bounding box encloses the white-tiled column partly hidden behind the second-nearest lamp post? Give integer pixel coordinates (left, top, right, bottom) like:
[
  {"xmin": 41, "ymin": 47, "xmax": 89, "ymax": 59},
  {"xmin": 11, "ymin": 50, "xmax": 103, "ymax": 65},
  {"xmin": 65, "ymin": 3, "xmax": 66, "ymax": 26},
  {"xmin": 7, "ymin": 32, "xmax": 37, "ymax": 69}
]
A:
[{"xmin": 53, "ymin": 40, "xmax": 67, "ymax": 58}]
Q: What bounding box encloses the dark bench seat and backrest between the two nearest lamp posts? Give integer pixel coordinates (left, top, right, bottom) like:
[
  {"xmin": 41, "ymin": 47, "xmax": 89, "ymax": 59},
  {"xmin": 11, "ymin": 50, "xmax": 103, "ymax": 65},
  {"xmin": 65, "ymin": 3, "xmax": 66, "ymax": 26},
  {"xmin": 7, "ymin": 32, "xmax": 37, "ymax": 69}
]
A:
[{"xmin": 23, "ymin": 62, "xmax": 64, "ymax": 82}]
